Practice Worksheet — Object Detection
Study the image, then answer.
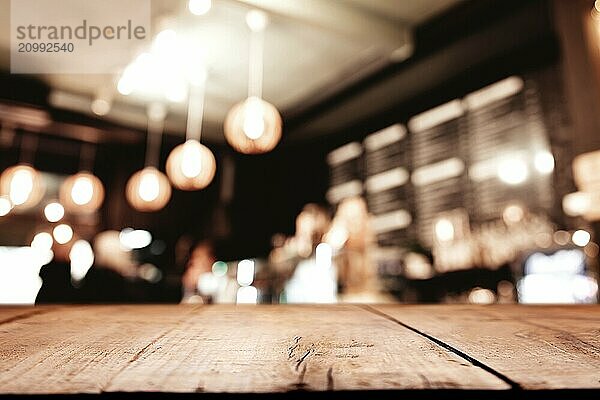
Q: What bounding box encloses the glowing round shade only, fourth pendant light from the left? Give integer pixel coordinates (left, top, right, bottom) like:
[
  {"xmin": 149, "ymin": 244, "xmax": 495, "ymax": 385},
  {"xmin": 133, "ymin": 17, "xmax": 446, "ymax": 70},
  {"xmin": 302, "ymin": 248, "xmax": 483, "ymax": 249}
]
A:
[{"xmin": 167, "ymin": 140, "xmax": 217, "ymax": 190}]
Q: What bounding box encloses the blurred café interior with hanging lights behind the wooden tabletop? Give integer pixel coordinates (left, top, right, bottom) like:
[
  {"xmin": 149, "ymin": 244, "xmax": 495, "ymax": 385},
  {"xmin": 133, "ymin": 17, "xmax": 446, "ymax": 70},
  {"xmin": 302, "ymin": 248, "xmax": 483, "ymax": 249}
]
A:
[{"xmin": 0, "ymin": 0, "xmax": 600, "ymax": 304}]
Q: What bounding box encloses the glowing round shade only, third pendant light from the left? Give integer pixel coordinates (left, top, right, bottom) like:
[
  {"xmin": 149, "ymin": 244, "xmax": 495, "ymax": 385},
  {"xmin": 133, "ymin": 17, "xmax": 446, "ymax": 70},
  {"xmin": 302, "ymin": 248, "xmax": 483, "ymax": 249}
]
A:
[{"xmin": 125, "ymin": 167, "xmax": 171, "ymax": 212}]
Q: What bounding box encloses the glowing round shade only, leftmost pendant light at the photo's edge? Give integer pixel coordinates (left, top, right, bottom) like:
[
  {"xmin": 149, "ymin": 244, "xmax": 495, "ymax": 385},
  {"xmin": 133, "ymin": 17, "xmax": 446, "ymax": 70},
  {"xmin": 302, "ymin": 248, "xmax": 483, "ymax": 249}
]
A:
[{"xmin": 0, "ymin": 164, "xmax": 46, "ymax": 209}]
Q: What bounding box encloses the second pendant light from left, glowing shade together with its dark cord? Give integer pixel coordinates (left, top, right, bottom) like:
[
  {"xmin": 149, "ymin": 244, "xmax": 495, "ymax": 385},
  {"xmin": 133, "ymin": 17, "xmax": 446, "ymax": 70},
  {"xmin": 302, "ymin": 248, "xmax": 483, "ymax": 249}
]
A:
[{"xmin": 59, "ymin": 143, "xmax": 104, "ymax": 214}]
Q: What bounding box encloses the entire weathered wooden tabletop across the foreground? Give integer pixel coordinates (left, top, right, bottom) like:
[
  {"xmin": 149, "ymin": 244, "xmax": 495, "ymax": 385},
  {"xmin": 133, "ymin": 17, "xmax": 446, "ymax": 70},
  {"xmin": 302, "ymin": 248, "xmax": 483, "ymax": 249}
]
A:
[{"xmin": 0, "ymin": 304, "xmax": 600, "ymax": 398}]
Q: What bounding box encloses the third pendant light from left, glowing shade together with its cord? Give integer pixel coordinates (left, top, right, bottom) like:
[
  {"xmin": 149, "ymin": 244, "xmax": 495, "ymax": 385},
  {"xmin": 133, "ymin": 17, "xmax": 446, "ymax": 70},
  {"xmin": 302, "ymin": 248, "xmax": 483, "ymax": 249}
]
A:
[{"xmin": 125, "ymin": 103, "xmax": 171, "ymax": 212}]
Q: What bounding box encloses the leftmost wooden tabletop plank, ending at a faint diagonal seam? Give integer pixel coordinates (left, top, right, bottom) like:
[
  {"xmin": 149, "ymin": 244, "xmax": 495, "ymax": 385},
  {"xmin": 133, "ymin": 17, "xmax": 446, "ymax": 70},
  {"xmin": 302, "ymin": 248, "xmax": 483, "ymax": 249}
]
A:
[{"xmin": 0, "ymin": 306, "xmax": 204, "ymax": 393}]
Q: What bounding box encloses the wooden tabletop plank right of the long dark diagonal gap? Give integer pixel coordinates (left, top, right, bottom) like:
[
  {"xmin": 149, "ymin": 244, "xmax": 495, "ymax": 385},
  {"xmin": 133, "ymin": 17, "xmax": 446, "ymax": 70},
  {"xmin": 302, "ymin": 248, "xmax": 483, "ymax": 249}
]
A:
[{"xmin": 373, "ymin": 305, "xmax": 600, "ymax": 389}]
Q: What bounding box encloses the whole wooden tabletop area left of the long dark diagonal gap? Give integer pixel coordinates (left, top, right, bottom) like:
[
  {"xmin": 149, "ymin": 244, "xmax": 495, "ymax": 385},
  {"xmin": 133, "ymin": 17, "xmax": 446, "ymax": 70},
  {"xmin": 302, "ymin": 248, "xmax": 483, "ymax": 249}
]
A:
[{"xmin": 0, "ymin": 305, "xmax": 509, "ymax": 394}]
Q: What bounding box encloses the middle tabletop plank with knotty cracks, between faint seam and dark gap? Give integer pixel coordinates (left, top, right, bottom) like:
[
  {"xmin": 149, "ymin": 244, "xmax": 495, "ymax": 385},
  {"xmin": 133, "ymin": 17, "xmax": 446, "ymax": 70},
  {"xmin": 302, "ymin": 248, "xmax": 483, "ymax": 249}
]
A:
[{"xmin": 107, "ymin": 305, "xmax": 508, "ymax": 392}]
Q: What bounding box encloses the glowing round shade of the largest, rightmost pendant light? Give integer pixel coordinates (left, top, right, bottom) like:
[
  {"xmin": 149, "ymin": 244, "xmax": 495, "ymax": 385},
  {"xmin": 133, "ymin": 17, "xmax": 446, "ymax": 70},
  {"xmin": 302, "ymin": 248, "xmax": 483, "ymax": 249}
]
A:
[{"xmin": 224, "ymin": 97, "xmax": 282, "ymax": 154}]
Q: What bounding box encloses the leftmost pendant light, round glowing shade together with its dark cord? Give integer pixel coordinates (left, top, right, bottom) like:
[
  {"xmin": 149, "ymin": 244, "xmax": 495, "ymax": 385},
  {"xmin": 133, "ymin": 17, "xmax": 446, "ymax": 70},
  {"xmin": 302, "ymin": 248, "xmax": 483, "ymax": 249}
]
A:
[{"xmin": 0, "ymin": 136, "xmax": 46, "ymax": 210}]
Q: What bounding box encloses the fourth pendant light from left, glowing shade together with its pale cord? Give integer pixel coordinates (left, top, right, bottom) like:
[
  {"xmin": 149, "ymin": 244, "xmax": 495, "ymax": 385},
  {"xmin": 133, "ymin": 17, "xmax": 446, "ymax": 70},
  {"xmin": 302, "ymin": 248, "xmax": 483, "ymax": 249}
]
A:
[{"xmin": 166, "ymin": 72, "xmax": 216, "ymax": 190}]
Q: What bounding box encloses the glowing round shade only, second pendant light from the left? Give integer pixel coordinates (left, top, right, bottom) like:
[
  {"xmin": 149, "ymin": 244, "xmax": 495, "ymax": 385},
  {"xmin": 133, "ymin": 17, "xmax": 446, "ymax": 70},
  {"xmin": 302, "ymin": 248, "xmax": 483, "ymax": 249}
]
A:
[{"xmin": 60, "ymin": 172, "xmax": 104, "ymax": 213}]
